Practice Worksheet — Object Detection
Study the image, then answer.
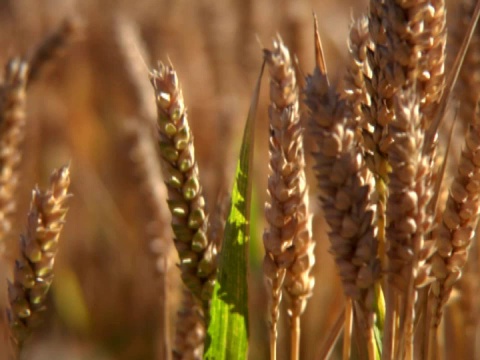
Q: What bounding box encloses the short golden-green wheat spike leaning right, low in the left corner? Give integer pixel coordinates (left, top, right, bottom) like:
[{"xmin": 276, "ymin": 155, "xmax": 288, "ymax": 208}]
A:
[{"xmin": 7, "ymin": 166, "xmax": 70, "ymax": 348}]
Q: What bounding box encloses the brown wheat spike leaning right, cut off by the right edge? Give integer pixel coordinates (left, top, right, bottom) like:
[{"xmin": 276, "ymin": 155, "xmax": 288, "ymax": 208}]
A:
[{"xmin": 430, "ymin": 100, "xmax": 480, "ymax": 328}]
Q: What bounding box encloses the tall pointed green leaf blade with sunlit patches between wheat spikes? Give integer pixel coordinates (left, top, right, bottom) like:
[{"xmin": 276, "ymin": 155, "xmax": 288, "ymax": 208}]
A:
[{"xmin": 204, "ymin": 65, "xmax": 264, "ymax": 360}]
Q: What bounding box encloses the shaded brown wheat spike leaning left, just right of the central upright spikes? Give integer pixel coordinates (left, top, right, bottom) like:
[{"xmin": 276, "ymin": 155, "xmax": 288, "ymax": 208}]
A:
[{"xmin": 305, "ymin": 61, "xmax": 380, "ymax": 359}]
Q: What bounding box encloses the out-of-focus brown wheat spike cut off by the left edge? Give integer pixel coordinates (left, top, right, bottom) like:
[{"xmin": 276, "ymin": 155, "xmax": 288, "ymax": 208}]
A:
[{"xmin": 0, "ymin": 59, "xmax": 28, "ymax": 254}]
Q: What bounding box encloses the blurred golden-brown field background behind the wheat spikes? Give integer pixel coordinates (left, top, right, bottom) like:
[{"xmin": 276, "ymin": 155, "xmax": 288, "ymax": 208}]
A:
[{"xmin": 0, "ymin": 0, "xmax": 476, "ymax": 360}]
